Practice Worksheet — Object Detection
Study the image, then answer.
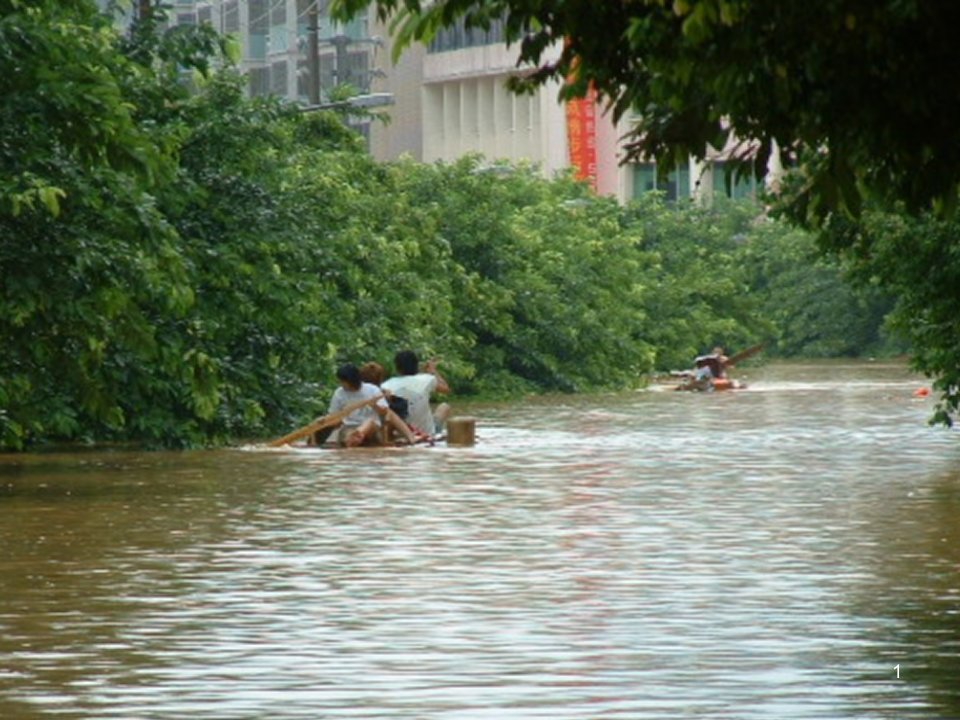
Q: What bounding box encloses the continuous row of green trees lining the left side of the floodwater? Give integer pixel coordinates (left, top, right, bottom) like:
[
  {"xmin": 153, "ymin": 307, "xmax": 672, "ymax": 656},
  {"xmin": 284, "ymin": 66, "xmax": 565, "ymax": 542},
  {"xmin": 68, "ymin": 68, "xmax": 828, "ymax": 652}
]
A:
[{"xmin": 0, "ymin": 0, "xmax": 916, "ymax": 449}]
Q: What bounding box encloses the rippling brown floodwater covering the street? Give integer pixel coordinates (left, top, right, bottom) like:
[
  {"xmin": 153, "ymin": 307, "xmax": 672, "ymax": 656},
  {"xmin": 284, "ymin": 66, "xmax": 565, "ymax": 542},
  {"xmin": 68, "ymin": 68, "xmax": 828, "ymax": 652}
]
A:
[{"xmin": 0, "ymin": 364, "xmax": 960, "ymax": 720}]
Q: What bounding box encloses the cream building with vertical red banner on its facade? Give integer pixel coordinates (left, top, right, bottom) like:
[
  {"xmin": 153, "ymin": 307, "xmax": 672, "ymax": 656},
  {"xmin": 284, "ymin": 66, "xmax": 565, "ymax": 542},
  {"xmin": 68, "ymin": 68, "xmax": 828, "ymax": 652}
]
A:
[{"xmin": 371, "ymin": 14, "xmax": 776, "ymax": 201}]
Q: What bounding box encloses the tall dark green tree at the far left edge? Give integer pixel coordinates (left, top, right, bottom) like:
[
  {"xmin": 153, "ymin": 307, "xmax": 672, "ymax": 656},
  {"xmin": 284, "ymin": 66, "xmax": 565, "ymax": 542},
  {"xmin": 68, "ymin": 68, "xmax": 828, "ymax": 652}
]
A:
[{"xmin": 0, "ymin": 0, "xmax": 190, "ymax": 447}]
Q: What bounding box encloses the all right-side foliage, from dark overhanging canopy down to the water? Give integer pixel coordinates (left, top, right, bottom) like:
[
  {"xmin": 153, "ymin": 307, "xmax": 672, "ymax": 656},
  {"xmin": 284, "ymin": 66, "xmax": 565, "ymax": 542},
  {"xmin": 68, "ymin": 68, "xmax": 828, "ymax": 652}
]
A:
[{"xmin": 331, "ymin": 0, "xmax": 960, "ymax": 424}]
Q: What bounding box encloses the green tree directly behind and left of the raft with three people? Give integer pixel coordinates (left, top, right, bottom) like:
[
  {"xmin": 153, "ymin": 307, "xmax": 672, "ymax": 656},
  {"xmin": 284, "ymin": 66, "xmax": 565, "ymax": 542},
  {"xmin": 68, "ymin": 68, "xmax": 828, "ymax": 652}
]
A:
[{"xmin": 144, "ymin": 76, "xmax": 466, "ymax": 439}]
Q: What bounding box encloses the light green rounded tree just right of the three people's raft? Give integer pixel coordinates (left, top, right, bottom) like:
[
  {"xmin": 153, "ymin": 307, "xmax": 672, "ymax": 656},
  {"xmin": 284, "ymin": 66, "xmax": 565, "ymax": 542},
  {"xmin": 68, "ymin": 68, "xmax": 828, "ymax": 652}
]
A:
[{"xmin": 392, "ymin": 157, "xmax": 654, "ymax": 393}]
